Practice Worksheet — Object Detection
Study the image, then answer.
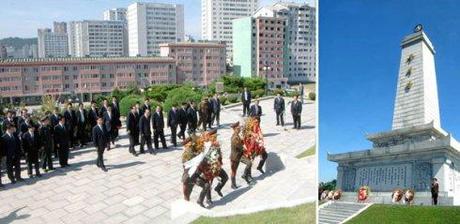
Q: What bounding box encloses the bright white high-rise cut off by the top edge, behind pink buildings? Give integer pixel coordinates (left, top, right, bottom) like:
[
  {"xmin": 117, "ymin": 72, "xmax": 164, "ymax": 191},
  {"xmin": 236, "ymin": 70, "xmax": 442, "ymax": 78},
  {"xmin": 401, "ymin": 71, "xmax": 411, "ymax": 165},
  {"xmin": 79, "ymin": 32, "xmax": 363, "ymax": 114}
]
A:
[{"xmin": 201, "ymin": 0, "xmax": 258, "ymax": 62}]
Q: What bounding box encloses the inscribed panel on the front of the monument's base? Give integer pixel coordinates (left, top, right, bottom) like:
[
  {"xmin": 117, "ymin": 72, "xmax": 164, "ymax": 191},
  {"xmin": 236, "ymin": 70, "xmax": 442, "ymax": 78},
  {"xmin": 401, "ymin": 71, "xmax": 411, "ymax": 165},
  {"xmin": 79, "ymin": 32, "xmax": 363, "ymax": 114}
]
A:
[{"xmin": 355, "ymin": 164, "xmax": 412, "ymax": 191}]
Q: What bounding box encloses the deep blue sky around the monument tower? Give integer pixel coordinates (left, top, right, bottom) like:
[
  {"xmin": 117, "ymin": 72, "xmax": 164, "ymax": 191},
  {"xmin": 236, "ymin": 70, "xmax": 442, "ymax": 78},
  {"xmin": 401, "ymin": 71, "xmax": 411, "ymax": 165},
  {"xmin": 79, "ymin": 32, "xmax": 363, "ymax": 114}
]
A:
[{"xmin": 319, "ymin": 0, "xmax": 460, "ymax": 182}]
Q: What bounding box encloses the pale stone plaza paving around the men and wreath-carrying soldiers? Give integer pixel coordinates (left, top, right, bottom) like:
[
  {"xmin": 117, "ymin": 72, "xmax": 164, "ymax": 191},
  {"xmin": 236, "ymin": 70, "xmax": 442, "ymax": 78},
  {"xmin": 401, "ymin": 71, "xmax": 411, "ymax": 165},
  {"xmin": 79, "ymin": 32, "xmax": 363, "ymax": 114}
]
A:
[{"xmin": 0, "ymin": 99, "xmax": 316, "ymax": 224}]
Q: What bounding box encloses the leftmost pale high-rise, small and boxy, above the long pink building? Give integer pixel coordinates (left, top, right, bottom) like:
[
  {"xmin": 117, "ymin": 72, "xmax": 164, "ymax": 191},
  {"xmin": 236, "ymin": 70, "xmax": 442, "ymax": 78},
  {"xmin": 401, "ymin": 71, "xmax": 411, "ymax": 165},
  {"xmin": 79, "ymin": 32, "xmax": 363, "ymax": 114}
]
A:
[{"xmin": 37, "ymin": 28, "xmax": 69, "ymax": 58}]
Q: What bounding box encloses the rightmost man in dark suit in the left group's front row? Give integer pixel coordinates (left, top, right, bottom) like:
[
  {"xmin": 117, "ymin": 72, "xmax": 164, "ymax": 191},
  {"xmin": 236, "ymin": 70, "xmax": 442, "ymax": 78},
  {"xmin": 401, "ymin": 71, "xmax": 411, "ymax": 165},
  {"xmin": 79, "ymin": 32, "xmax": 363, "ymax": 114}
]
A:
[{"xmin": 54, "ymin": 116, "xmax": 70, "ymax": 167}]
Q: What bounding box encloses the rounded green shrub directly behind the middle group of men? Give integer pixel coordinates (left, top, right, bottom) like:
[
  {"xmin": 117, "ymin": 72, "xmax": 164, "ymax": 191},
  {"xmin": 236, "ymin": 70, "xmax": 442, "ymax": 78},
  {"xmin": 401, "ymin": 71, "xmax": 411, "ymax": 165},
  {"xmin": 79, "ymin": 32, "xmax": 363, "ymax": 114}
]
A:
[{"xmin": 163, "ymin": 85, "xmax": 202, "ymax": 112}]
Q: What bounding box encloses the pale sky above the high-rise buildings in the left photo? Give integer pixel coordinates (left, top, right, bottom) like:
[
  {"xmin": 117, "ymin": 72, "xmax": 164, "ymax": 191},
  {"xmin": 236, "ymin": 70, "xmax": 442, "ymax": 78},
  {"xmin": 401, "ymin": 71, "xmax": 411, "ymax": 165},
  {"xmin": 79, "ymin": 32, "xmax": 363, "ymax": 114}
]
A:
[{"xmin": 0, "ymin": 0, "xmax": 313, "ymax": 39}]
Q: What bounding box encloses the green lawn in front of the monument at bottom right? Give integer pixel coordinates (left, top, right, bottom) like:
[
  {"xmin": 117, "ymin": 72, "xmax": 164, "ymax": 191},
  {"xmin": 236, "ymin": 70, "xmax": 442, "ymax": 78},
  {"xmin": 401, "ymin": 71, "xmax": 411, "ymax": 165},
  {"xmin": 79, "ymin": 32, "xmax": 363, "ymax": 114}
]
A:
[{"xmin": 347, "ymin": 205, "xmax": 460, "ymax": 224}]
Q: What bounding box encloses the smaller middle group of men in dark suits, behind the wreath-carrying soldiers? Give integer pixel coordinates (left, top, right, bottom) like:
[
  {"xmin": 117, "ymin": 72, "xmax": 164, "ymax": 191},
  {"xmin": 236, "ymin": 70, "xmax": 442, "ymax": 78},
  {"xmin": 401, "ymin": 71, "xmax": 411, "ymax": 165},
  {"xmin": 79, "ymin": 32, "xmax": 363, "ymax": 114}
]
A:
[{"xmin": 126, "ymin": 94, "xmax": 221, "ymax": 155}]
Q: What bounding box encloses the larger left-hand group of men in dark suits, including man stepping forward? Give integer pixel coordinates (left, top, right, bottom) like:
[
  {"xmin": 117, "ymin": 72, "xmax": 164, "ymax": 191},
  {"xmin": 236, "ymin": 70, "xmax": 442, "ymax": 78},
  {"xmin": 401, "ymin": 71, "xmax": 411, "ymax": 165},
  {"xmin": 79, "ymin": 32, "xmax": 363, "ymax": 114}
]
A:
[{"xmin": 0, "ymin": 97, "xmax": 121, "ymax": 186}]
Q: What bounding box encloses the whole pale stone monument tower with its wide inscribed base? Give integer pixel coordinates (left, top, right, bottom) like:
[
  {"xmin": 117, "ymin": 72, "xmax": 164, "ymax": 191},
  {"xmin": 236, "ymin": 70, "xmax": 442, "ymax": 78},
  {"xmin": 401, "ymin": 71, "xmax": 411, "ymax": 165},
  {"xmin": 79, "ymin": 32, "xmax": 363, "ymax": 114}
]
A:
[{"xmin": 328, "ymin": 25, "xmax": 460, "ymax": 205}]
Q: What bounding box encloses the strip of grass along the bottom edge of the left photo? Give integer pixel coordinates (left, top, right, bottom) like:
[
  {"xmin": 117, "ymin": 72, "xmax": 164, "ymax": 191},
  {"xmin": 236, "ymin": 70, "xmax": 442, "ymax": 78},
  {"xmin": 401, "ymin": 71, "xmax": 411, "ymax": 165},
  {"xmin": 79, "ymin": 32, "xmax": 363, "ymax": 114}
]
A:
[{"xmin": 193, "ymin": 203, "xmax": 316, "ymax": 224}]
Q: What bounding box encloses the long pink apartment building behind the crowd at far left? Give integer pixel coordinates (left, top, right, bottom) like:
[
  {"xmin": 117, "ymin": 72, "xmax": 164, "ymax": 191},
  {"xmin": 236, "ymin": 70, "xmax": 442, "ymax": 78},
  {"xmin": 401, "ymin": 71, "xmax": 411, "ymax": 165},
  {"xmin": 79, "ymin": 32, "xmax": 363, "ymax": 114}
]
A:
[{"xmin": 0, "ymin": 57, "xmax": 176, "ymax": 103}]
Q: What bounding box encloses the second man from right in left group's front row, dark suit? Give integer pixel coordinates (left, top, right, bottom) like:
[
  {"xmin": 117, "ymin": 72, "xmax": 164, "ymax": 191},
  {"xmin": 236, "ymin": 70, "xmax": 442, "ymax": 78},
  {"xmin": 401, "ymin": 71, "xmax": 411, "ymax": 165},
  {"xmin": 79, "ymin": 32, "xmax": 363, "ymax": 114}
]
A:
[{"xmin": 38, "ymin": 117, "xmax": 54, "ymax": 172}]
